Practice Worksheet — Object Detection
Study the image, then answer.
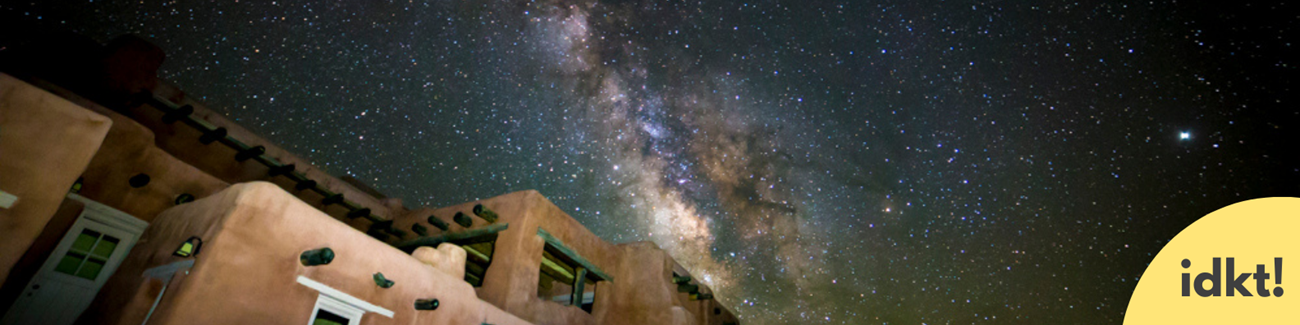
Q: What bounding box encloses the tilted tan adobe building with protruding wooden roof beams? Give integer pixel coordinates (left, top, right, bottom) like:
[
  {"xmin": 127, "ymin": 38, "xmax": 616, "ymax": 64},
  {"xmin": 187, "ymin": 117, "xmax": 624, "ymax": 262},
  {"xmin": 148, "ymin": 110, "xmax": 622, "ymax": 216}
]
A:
[{"xmin": 0, "ymin": 34, "xmax": 737, "ymax": 325}]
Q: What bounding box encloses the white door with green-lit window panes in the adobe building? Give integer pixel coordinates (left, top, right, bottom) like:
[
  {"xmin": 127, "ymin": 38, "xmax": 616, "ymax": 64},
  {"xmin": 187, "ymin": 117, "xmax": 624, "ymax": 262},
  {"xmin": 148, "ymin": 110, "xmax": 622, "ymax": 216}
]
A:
[{"xmin": 0, "ymin": 195, "xmax": 143, "ymax": 325}]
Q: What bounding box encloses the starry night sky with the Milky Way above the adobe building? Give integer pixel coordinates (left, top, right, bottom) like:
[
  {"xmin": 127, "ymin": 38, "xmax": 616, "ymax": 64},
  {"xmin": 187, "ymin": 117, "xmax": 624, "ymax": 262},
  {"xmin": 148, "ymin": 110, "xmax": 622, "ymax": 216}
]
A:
[{"xmin": 0, "ymin": 0, "xmax": 1300, "ymax": 324}]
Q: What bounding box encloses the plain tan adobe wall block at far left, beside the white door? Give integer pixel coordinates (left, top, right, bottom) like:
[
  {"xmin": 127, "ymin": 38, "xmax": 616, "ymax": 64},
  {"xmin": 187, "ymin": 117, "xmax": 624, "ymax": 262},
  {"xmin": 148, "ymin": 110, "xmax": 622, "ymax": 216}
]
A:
[{"xmin": 0, "ymin": 74, "xmax": 112, "ymax": 282}]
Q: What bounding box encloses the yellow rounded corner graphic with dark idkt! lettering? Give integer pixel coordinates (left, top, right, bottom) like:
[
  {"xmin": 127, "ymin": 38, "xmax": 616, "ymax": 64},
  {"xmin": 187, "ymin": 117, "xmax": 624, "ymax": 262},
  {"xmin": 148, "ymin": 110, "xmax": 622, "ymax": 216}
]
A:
[{"xmin": 1125, "ymin": 198, "xmax": 1300, "ymax": 324}]
